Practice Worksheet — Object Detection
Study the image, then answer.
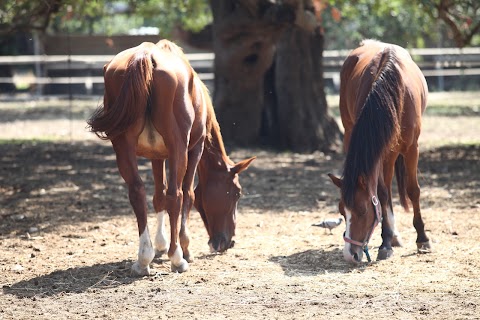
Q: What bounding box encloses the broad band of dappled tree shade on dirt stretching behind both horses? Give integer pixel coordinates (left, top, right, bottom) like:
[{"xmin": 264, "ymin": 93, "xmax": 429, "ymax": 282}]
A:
[{"xmin": 0, "ymin": 142, "xmax": 480, "ymax": 239}]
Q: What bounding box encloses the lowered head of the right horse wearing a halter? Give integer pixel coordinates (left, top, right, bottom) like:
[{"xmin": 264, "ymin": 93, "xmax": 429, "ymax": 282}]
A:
[{"xmin": 328, "ymin": 174, "xmax": 381, "ymax": 264}]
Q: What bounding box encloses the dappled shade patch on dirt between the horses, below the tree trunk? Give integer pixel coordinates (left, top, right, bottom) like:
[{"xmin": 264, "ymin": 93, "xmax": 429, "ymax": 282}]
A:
[{"xmin": 239, "ymin": 150, "xmax": 343, "ymax": 211}]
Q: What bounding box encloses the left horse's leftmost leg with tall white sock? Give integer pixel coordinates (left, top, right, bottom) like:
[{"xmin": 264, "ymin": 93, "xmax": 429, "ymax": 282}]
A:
[{"xmin": 112, "ymin": 137, "xmax": 155, "ymax": 276}]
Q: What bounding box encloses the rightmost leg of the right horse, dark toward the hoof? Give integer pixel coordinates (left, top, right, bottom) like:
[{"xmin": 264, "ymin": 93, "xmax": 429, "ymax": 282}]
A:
[{"xmin": 405, "ymin": 145, "xmax": 431, "ymax": 253}]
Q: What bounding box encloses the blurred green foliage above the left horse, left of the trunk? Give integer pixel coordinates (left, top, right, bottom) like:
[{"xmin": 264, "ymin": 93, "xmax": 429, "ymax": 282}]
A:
[{"xmin": 0, "ymin": 0, "xmax": 212, "ymax": 36}]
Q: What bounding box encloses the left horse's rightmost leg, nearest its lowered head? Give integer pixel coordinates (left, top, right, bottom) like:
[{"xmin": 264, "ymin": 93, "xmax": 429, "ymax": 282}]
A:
[{"xmin": 179, "ymin": 142, "xmax": 203, "ymax": 262}]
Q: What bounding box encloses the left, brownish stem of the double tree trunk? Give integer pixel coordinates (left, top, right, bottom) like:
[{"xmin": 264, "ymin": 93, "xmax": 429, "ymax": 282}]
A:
[{"xmin": 211, "ymin": 0, "xmax": 294, "ymax": 146}]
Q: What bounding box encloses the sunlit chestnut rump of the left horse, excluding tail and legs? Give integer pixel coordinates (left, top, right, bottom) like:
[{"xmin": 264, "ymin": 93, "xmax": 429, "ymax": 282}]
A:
[{"xmin": 99, "ymin": 42, "xmax": 205, "ymax": 159}]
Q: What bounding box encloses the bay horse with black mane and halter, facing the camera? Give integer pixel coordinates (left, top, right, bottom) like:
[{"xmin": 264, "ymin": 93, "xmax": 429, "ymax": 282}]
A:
[{"xmin": 329, "ymin": 40, "xmax": 430, "ymax": 263}]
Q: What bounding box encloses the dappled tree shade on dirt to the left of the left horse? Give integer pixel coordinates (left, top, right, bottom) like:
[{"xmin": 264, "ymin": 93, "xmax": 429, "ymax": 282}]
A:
[{"xmin": 0, "ymin": 142, "xmax": 153, "ymax": 235}]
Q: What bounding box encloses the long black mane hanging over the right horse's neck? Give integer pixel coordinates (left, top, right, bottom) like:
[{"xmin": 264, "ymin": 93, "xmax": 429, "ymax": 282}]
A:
[{"xmin": 342, "ymin": 47, "xmax": 403, "ymax": 206}]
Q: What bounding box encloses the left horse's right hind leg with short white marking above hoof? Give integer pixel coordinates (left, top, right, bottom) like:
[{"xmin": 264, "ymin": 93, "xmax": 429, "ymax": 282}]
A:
[{"xmin": 166, "ymin": 147, "xmax": 188, "ymax": 273}]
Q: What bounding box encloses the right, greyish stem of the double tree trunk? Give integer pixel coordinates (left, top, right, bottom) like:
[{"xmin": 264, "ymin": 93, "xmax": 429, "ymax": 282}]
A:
[{"xmin": 263, "ymin": 27, "xmax": 341, "ymax": 152}]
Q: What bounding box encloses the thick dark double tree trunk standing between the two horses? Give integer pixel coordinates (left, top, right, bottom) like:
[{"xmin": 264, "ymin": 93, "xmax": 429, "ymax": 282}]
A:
[{"xmin": 210, "ymin": 0, "xmax": 340, "ymax": 151}]
